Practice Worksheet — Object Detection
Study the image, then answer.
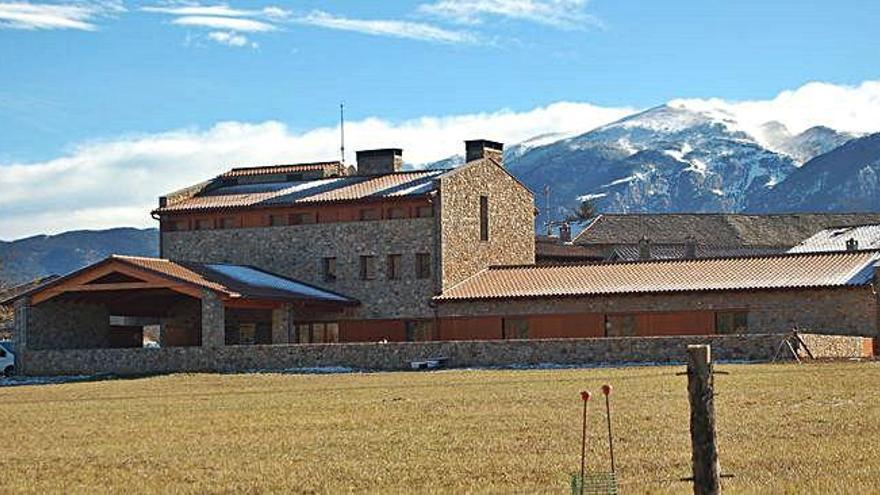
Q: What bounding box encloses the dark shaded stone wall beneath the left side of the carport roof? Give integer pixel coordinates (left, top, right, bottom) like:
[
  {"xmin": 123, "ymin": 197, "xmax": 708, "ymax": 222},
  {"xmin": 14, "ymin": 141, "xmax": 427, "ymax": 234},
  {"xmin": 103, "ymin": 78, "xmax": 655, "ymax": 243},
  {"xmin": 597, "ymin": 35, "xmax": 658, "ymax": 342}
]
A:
[{"xmin": 24, "ymin": 300, "xmax": 110, "ymax": 350}]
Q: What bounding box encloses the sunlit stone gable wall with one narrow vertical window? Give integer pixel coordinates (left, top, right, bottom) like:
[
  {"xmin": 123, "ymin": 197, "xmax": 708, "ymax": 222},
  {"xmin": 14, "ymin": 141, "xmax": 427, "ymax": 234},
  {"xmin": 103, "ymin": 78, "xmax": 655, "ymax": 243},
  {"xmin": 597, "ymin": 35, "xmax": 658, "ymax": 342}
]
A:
[{"xmin": 439, "ymin": 160, "xmax": 535, "ymax": 288}]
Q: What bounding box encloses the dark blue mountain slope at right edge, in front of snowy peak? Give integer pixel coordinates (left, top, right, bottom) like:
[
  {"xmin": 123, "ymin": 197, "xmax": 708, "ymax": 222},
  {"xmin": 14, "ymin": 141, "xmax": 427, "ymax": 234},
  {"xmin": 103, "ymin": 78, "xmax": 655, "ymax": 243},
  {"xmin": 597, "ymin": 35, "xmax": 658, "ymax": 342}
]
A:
[{"xmin": 747, "ymin": 134, "xmax": 880, "ymax": 212}]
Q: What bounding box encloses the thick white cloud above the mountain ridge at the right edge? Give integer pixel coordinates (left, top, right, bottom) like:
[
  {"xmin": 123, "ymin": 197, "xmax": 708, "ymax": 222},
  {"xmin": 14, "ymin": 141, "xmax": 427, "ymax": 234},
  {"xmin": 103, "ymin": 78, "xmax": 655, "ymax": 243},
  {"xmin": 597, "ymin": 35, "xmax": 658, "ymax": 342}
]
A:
[{"xmin": 670, "ymin": 80, "xmax": 880, "ymax": 138}]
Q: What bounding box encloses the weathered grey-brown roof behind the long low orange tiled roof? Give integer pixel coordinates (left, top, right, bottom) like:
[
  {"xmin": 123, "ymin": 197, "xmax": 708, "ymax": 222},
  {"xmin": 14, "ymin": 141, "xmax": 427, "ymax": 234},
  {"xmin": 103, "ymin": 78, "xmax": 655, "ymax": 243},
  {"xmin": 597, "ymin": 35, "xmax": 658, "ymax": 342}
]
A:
[{"xmin": 574, "ymin": 213, "xmax": 880, "ymax": 248}]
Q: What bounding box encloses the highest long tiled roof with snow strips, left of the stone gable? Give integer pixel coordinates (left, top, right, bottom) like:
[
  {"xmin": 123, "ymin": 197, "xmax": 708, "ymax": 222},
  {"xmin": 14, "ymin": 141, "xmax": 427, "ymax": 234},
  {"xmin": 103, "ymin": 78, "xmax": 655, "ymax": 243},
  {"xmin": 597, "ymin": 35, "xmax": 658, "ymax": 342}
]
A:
[{"xmin": 155, "ymin": 170, "xmax": 445, "ymax": 213}]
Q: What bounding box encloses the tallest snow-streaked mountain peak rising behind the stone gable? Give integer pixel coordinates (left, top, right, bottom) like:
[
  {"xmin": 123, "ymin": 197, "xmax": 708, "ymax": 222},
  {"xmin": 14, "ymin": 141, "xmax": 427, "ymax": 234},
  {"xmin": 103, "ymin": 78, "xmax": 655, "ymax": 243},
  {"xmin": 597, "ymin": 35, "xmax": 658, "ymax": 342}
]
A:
[{"xmin": 507, "ymin": 105, "xmax": 800, "ymax": 225}]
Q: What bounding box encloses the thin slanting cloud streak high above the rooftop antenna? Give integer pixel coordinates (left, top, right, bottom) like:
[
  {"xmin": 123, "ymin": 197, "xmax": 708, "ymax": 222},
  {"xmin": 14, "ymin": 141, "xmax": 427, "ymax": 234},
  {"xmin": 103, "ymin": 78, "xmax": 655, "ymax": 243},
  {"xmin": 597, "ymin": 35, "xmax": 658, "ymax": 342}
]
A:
[{"xmin": 295, "ymin": 10, "xmax": 476, "ymax": 43}]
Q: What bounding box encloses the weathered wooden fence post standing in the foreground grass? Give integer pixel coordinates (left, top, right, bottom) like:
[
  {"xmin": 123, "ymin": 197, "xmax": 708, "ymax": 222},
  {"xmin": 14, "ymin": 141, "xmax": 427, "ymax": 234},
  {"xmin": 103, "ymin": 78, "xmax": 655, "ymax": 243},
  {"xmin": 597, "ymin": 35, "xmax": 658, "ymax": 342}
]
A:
[{"xmin": 687, "ymin": 345, "xmax": 721, "ymax": 495}]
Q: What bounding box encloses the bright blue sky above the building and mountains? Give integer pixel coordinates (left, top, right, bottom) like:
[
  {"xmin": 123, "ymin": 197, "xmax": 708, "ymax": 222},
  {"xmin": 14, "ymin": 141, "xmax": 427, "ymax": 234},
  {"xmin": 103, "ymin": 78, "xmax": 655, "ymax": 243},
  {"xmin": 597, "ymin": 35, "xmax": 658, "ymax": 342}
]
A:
[{"xmin": 0, "ymin": 0, "xmax": 880, "ymax": 238}]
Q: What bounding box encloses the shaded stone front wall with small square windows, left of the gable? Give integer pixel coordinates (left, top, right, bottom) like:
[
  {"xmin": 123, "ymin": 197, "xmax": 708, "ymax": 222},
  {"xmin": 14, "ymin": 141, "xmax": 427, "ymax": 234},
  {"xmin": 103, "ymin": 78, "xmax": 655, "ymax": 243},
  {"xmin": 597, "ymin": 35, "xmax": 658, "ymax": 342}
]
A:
[{"xmin": 161, "ymin": 218, "xmax": 436, "ymax": 318}]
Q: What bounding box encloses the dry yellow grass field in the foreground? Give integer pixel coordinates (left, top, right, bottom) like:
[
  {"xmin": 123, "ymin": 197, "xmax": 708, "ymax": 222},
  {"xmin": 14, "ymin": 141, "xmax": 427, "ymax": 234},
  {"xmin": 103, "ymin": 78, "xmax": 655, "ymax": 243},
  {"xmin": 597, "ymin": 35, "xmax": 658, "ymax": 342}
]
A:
[{"xmin": 0, "ymin": 362, "xmax": 880, "ymax": 493}]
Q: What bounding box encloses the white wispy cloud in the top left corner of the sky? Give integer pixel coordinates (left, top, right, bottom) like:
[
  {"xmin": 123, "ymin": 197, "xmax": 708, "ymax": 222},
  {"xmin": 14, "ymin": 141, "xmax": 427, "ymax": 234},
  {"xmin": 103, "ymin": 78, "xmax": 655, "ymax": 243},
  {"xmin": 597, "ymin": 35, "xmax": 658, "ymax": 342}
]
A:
[{"xmin": 0, "ymin": 0, "xmax": 124, "ymax": 31}]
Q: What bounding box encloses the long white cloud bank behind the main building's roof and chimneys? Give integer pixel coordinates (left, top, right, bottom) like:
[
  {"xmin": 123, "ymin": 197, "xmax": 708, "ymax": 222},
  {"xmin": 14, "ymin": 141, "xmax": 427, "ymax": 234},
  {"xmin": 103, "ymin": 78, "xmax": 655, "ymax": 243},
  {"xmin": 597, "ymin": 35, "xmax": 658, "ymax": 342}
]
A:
[{"xmin": 0, "ymin": 103, "xmax": 632, "ymax": 239}]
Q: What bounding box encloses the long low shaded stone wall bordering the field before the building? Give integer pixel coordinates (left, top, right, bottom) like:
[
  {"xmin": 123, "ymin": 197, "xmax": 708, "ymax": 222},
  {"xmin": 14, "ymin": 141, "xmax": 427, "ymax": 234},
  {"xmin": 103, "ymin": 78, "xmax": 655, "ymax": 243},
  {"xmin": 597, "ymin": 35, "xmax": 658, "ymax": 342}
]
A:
[{"xmin": 23, "ymin": 334, "xmax": 796, "ymax": 375}]
